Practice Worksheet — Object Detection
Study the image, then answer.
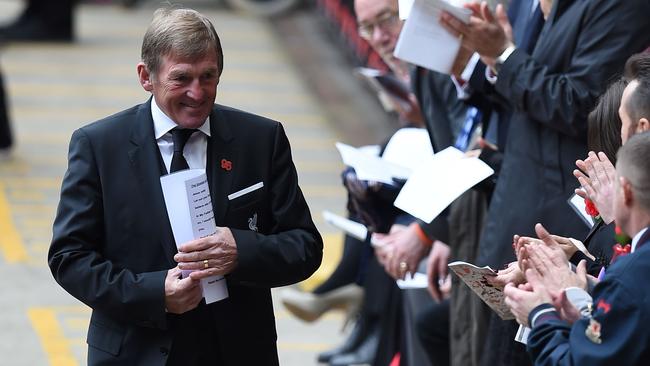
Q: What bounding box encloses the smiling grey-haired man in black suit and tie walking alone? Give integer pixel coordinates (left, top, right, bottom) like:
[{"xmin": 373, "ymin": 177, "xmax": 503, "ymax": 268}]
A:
[{"xmin": 48, "ymin": 9, "xmax": 322, "ymax": 365}]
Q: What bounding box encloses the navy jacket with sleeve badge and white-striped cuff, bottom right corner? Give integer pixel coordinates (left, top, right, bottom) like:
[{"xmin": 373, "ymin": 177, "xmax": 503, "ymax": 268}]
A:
[{"xmin": 528, "ymin": 229, "xmax": 650, "ymax": 366}]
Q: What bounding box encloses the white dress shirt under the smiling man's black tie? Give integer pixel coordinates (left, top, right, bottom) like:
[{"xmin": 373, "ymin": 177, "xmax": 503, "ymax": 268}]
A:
[{"xmin": 151, "ymin": 98, "xmax": 210, "ymax": 172}]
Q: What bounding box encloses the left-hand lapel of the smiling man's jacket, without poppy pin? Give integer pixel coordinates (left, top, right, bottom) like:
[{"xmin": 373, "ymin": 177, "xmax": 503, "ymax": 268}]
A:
[{"xmin": 128, "ymin": 99, "xmax": 177, "ymax": 267}]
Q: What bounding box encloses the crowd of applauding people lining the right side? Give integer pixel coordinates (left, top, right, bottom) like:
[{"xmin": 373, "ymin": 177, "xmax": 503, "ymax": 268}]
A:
[{"xmin": 283, "ymin": 0, "xmax": 650, "ymax": 366}]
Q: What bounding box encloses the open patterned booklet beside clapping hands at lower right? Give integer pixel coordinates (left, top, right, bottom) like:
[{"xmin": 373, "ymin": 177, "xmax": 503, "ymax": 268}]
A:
[{"xmin": 449, "ymin": 261, "xmax": 515, "ymax": 320}]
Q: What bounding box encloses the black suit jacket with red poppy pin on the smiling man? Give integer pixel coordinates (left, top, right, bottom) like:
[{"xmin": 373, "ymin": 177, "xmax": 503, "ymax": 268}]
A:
[{"xmin": 48, "ymin": 99, "xmax": 322, "ymax": 365}]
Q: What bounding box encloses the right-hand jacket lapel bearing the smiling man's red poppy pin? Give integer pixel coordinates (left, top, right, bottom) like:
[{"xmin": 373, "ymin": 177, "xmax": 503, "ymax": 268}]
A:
[{"xmin": 205, "ymin": 106, "xmax": 235, "ymax": 226}]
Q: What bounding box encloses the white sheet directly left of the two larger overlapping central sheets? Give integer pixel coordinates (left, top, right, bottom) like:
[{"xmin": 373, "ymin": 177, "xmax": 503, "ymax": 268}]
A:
[{"xmin": 336, "ymin": 142, "xmax": 410, "ymax": 184}]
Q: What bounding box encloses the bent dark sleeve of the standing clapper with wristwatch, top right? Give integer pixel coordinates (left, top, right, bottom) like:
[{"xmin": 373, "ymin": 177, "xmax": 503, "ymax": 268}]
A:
[{"xmin": 495, "ymin": 0, "xmax": 650, "ymax": 137}]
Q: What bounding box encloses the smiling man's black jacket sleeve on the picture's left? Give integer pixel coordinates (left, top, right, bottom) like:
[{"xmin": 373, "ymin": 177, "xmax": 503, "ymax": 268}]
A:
[{"xmin": 48, "ymin": 130, "xmax": 167, "ymax": 328}]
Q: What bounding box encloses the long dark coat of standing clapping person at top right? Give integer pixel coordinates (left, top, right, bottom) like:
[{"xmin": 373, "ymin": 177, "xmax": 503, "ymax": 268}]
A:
[{"xmin": 479, "ymin": 0, "xmax": 650, "ymax": 266}]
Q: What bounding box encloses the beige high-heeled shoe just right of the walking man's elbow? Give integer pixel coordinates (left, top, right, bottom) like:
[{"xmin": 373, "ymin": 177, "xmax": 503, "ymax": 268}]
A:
[{"xmin": 280, "ymin": 284, "xmax": 363, "ymax": 323}]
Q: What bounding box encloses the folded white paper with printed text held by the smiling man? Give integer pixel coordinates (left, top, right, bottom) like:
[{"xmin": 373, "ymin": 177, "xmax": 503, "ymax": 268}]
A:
[{"xmin": 160, "ymin": 169, "xmax": 228, "ymax": 304}]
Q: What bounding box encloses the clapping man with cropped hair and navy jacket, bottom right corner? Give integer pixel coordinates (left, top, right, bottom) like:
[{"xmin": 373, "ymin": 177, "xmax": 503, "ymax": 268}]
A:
[{"xmin": 505, "ymin": 132, "xmax": 650, "ymax": 365}]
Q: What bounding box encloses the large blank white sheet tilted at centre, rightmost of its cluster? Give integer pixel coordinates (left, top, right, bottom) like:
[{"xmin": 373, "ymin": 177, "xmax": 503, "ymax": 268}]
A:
[{"xmin": 394, "ymin": 147, "xmax": 494, "ymax": 222}]
